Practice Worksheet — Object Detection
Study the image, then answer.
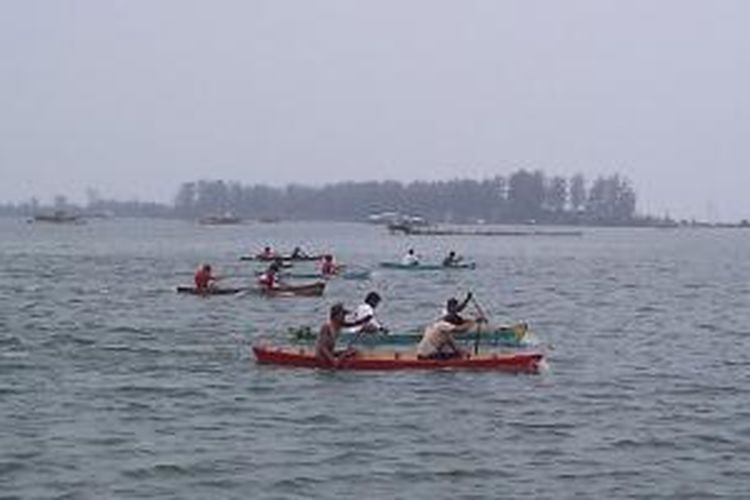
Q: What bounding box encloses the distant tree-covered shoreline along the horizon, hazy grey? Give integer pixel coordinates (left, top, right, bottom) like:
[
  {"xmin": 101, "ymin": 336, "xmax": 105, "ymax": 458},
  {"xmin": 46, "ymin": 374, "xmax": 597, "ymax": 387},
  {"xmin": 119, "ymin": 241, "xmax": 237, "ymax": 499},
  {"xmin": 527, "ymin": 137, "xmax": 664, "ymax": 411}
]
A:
[{"xmin": 0, "ymin": 169, "xmax": 750, "ymax": 227}]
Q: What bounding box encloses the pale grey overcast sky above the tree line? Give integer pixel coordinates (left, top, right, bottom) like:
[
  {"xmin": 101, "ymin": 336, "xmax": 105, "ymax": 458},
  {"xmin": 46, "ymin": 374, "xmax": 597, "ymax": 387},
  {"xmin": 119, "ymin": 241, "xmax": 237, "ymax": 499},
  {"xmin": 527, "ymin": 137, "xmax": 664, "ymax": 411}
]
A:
[{"xmin": 0, "ymin": 0, "xmax": 750, "ymax": 220}]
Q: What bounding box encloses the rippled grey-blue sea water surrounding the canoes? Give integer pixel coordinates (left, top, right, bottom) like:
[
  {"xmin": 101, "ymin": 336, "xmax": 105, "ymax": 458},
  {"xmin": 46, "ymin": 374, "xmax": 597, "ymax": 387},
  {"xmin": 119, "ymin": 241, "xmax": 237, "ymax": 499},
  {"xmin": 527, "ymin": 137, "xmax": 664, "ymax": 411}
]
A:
[{"xmin": 0, "ymin": 218, "xmax": 750, "ymax": 499}]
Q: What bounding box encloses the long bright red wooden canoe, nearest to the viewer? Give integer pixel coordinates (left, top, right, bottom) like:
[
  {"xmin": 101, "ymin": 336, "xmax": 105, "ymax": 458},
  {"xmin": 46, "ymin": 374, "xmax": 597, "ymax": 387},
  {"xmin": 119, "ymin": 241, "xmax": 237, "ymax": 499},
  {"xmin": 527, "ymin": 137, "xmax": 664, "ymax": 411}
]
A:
[{"xmin": 253, "ymin": 345, "xmax": 544, "ymax": 373}]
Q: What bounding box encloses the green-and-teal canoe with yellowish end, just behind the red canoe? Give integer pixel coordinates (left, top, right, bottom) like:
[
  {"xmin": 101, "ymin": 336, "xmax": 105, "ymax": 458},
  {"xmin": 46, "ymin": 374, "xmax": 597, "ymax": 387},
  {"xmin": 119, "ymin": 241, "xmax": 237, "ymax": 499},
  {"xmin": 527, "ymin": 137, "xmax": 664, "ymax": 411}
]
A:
[{"xmin": 288, "ymin": 323, "xmax": 538, "ymax": 347}]
